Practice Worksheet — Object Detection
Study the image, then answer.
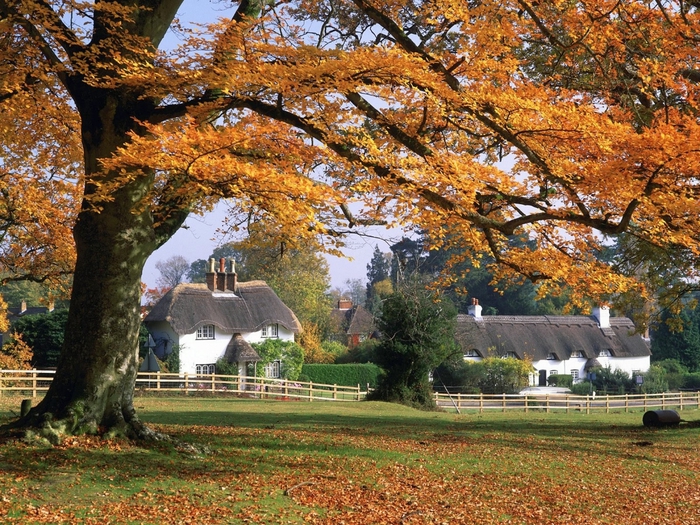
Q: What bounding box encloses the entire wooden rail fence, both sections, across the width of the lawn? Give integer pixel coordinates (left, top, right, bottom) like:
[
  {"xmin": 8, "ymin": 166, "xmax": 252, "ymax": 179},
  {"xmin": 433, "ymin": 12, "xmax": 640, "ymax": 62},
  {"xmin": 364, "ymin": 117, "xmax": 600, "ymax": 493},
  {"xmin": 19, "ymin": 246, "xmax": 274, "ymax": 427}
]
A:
[{"xmin": 0, "ymin": 370, "xmax": 700, "ymax": 414}]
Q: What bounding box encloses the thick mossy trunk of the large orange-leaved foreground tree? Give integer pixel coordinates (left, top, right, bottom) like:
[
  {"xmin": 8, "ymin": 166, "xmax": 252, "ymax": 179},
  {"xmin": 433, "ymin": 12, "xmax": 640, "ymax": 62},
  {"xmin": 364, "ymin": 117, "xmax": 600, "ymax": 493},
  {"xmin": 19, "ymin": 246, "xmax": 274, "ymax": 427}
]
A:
[{"xmin": 11, "ymin": 92, "xmax": 173, "ymax": 442}]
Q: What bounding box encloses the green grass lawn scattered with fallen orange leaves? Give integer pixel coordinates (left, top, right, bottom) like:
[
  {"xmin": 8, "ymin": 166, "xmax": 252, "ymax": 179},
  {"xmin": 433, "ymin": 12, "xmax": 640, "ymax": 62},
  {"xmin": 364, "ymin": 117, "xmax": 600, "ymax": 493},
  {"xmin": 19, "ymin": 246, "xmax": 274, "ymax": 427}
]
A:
[{"xmin": 0, "ymin": 397, "xmax": 700, "ymax": 525}]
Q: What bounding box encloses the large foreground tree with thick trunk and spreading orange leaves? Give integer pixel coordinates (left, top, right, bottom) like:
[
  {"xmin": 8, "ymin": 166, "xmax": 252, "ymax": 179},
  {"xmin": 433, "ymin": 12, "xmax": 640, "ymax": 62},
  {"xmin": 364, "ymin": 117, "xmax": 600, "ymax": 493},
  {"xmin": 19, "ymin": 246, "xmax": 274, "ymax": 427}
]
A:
[{"xmin": 0, "ymin": 0, "xmax": 700, "ymax": 438}]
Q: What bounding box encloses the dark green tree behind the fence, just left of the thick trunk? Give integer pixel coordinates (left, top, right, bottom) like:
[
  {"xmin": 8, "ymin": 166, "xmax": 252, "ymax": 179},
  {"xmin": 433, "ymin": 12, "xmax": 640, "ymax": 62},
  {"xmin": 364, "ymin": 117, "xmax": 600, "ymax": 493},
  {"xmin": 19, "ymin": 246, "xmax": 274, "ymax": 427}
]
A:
[{"xmin": 12, "ymin": 309, "xmax": 68, "ymax": 368}]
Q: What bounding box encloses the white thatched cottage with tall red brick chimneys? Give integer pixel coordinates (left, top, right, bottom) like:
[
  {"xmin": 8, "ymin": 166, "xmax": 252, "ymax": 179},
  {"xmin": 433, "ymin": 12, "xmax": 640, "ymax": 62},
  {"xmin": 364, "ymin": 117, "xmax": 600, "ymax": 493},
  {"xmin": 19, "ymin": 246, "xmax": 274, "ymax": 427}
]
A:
[{"xmin": 144, "ymin": 259, "xmax": 301, "ymax": 377}]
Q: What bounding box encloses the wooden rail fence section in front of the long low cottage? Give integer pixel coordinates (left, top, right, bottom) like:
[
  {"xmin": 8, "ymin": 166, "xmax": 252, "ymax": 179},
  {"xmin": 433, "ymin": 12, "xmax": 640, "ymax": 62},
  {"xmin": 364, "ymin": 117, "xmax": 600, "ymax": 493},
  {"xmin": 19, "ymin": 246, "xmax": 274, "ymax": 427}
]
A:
[{"xmin": 435, "ymin": 392, "xmax": 700, "ymax": 414}]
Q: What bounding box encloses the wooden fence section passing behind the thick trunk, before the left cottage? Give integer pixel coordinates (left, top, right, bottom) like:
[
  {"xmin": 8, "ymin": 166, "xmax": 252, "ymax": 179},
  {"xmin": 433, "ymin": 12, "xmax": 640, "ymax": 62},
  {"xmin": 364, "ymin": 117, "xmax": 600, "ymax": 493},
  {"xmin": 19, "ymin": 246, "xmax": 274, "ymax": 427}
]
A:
[{"xmin": 0, "ymin": 370, "xmax": 368, "ymax": 401}]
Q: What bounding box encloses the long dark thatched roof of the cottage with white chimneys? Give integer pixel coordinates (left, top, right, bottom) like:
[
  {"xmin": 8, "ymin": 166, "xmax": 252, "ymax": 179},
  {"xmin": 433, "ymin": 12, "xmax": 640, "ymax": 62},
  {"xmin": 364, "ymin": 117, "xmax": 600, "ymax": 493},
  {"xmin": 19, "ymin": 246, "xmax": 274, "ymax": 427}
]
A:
[{"xmin": 456, "ymin": 315, "xmax": 651, "ymax": 361}]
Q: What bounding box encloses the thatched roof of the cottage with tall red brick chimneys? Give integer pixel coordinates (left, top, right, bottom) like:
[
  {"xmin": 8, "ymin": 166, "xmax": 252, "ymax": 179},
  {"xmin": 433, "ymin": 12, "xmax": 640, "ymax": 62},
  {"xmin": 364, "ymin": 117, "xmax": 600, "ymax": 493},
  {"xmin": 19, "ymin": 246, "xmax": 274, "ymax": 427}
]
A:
[{"xmin": 144, "ymin": 281, "xmax": 301, "ymax": 335}]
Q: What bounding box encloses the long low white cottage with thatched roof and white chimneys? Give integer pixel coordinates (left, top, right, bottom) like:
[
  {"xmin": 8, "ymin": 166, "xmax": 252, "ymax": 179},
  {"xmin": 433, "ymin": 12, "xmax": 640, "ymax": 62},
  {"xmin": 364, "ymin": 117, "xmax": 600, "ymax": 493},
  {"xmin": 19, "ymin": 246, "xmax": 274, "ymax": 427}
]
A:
[{"xmin": 456, "ymin": 300, "xmax": 651, "ymax": 386}]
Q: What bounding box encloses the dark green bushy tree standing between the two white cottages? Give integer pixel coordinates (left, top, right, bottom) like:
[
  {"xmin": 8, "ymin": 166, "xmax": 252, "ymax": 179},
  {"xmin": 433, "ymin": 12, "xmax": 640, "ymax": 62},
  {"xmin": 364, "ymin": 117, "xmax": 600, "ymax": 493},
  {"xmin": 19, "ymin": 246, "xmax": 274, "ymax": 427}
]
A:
[{"xmin": 368, "ymin": 278, "xmax": 458, "ymax": 409}]
